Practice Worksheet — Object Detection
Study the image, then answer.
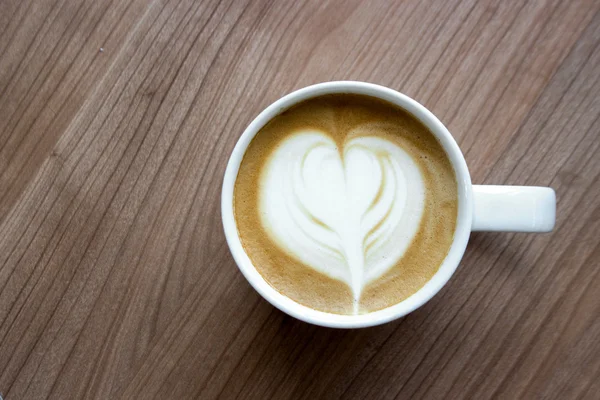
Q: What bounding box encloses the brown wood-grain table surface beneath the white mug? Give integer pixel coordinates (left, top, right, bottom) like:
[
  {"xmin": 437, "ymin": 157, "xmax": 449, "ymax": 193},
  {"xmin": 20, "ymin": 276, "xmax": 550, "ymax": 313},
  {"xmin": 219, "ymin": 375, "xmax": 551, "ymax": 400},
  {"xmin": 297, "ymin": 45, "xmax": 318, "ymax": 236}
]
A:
[{"xmin": 0, "ymin": 0, "xmax": 600, "ymax": 399}]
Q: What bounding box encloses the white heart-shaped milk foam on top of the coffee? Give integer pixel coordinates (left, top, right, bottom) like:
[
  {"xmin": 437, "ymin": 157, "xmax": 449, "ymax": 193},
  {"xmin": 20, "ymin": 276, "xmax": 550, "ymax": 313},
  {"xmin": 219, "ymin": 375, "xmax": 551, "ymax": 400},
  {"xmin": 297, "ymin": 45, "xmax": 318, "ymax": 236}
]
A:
[{"xmin": 259, "ymin": 130, "xmax": 425, "ymax": 313}]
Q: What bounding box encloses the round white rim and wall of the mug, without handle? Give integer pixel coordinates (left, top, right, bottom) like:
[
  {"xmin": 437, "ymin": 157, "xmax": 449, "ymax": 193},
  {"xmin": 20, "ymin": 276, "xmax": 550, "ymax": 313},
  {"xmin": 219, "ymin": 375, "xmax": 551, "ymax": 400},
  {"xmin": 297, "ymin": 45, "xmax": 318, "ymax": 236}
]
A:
[{"xmin": 221, "ymin": 81, "xmax": 473, "ymax": 328}]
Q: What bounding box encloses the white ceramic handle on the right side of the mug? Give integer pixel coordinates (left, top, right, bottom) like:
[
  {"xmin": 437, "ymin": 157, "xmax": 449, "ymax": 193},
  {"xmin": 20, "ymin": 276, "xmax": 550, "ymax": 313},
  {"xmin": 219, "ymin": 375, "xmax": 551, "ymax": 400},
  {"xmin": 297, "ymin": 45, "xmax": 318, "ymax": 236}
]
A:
[{"xmin": 471, "ymin": 185, "xmax": 556, "ymax": 232}]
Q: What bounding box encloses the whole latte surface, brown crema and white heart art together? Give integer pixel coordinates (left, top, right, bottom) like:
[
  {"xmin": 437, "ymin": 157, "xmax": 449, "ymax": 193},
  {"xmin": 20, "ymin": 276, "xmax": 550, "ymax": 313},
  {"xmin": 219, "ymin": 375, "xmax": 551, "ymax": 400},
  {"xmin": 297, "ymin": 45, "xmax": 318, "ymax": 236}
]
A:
[{"xmin": 234, "ymin": 94, "xmax": 458, "ymax": 314}]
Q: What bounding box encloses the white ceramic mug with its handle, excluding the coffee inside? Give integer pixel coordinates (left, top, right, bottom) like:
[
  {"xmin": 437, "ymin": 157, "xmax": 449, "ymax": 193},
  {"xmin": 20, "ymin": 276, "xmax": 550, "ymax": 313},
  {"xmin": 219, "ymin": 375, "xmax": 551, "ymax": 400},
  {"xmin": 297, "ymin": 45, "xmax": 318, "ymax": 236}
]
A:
[{"xmin": 221, "ymin": 81, "xmax": 556, "ymax": 328}]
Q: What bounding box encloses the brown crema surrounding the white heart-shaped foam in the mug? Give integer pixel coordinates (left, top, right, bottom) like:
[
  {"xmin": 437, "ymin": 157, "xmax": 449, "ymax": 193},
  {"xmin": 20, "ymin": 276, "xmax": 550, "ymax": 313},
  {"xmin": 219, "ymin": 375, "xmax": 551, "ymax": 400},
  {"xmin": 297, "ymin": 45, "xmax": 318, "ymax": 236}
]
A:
[{"xmin": 234, "ymin": 94, "xmax": 458, "ymax": 314}]
